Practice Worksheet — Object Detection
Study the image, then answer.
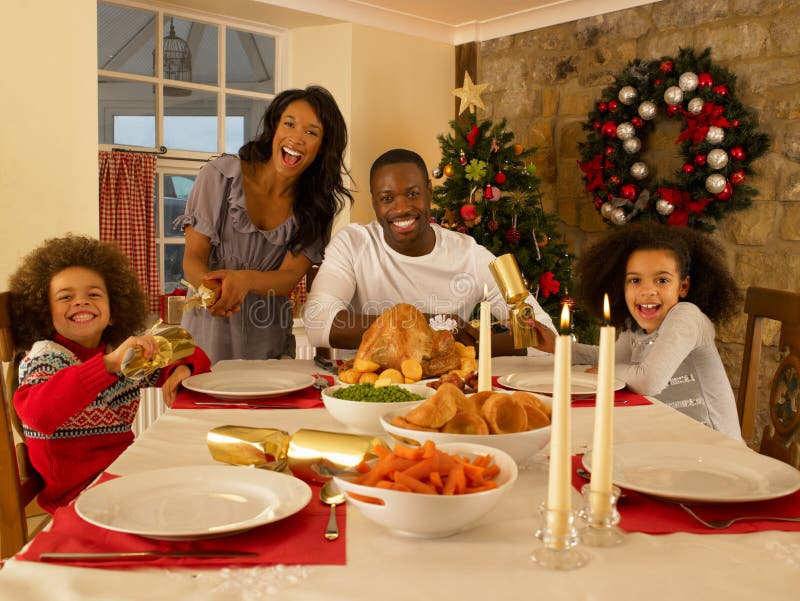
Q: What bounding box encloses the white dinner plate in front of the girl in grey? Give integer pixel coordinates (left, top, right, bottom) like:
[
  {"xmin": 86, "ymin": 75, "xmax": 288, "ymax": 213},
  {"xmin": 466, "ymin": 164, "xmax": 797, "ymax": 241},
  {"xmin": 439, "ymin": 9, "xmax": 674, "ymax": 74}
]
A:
[{"xmin": 583, "ymin": 442, "xmax": 800, "ymax": 503}]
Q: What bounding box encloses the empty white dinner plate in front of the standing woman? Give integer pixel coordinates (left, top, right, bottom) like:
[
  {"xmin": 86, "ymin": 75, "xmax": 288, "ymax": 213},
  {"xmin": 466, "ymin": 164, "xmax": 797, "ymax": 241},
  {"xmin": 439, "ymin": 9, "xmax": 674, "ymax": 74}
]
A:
[{"xmin": 183, "ymin": 369, "xmax": 314, "ymax": 399}]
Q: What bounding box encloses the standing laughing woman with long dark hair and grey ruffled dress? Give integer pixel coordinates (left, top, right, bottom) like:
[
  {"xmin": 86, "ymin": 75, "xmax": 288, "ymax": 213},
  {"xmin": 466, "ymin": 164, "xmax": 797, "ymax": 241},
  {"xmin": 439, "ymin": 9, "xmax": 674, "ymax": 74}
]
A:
[{"xmin": 174, "ymin": 86, "xmax": 352, "ymax": 362}]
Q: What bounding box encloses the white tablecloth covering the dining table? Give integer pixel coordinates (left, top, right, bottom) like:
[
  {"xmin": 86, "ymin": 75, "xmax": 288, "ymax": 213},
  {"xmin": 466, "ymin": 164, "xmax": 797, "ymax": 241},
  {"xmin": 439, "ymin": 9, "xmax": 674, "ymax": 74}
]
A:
[{"xmin": 0, "ymin": 357, "xmax": 800, "ymax": 601}]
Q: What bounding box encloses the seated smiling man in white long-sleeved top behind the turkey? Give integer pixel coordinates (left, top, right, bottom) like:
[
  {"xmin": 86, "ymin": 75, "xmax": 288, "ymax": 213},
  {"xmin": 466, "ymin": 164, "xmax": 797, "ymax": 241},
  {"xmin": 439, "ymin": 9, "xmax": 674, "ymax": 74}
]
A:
[{"xmin": 303, "ymin": 149, "xmax": 555, "ymax": 355}]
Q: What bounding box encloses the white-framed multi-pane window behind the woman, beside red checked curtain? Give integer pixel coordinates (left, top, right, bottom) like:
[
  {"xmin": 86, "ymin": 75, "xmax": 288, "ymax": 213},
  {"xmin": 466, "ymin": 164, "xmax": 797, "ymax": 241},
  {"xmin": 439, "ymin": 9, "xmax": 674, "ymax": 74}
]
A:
[{"xmin": 97, "ymin": 0, "xmax": 285, "ymax": 293}]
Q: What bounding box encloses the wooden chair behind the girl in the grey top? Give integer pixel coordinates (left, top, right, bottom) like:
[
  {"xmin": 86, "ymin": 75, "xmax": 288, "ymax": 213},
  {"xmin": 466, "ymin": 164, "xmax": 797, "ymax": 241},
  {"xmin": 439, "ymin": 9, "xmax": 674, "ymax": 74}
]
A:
[{"xmin": 737, "ymin": 287, "xmax": 800, "ymax": 469}]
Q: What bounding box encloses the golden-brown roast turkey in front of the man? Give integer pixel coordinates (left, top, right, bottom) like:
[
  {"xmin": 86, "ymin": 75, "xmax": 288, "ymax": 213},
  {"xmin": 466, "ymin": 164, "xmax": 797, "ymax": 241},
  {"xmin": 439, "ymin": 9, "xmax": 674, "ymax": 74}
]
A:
[{"xmin": 356, "ymin": 303, "xmax": 461, "ymax": 378}]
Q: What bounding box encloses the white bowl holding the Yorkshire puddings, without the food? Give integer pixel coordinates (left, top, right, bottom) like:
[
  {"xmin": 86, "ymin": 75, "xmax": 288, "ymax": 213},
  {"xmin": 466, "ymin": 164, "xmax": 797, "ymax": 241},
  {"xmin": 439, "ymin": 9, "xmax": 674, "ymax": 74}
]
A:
[{"xmin": 380, "ymin": 396, "xmax": 550, "ymax": 463}]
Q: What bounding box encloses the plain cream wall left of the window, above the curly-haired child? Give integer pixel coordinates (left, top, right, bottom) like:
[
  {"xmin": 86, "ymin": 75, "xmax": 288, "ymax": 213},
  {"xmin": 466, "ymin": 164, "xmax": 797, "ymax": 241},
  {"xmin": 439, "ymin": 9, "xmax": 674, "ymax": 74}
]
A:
[{"xmin": 0, "ymin": 0, "xmax": 99, "ymax": 290}]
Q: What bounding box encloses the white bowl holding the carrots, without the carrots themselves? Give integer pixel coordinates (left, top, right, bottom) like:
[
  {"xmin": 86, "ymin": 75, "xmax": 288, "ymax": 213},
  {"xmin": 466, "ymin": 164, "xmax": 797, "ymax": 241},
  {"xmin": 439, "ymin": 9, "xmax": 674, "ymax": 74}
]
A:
[{"xmin": 334, "ymin": 442, "xmax": 517, "ymax": 538}]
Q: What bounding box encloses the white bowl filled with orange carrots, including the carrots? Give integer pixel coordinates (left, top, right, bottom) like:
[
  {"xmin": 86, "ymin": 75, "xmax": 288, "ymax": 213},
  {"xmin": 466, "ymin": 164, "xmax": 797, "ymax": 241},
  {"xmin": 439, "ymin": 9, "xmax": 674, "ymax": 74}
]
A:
[{"xmin": 334, "ymin": 441, "xmax": 517, "ymax": 538}]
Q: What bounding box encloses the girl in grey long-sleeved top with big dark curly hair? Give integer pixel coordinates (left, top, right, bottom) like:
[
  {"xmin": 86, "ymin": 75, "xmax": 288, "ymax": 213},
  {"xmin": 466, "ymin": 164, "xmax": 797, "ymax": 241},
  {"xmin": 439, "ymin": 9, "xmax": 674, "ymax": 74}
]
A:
[{"xmin": 573, "ymin": 224, "xmax": 741, "ymax": 440}]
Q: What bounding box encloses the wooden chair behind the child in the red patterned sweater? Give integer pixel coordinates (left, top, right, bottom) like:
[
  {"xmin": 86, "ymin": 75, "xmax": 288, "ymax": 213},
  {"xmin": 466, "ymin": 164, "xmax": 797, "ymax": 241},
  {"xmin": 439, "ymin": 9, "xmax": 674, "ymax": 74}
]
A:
[{"xmin": 0, "ymin": 292, "xmax": 44, "ymax": 557}]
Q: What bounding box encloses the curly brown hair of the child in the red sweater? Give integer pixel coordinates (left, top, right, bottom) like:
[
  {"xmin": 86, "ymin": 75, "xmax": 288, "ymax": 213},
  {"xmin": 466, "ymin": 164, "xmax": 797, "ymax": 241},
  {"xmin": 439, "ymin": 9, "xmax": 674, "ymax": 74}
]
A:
[{"xmin": 9, "ymin": 234, "xmax": 147, "ymax": 349}]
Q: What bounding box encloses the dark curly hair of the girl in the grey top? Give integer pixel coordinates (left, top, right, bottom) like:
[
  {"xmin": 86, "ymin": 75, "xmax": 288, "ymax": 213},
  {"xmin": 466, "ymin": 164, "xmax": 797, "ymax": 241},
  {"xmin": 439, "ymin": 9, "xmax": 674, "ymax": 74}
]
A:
[{"xmin": 575, "ymin": 222, "xmax": 741, "ymax": 329}]
